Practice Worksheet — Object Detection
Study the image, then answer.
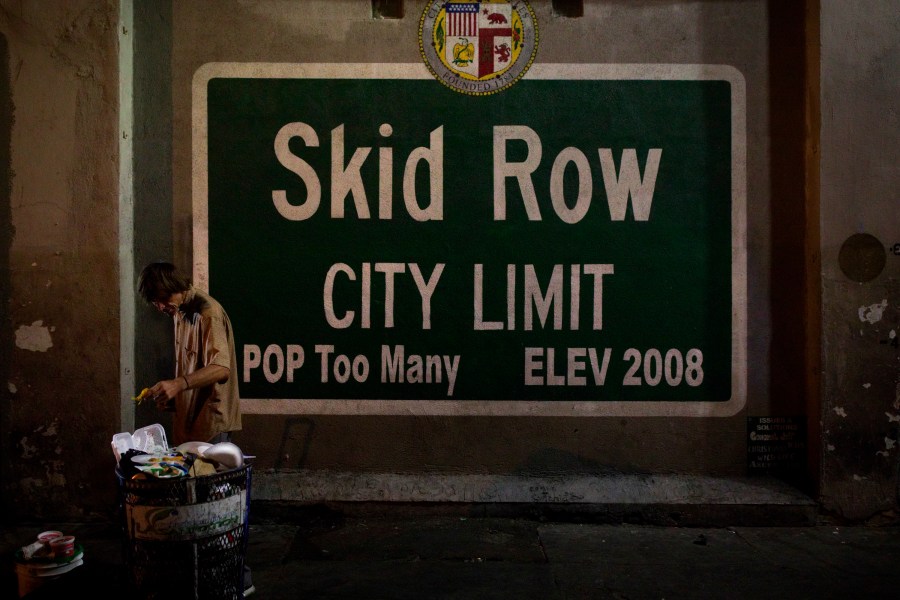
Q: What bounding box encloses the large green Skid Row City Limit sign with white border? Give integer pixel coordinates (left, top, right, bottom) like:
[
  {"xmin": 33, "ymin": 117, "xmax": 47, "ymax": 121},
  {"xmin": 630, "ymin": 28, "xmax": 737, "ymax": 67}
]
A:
[{"xmin": 192, "ymin": 63, "xmax": 747, "ymax": 417}]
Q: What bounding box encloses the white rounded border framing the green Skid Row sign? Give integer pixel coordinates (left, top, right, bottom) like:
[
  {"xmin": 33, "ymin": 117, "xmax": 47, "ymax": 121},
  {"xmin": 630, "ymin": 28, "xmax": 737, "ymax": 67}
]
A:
[{"xmin": 192, "ymin": 63, "xmax": 747, "ymax": 417}]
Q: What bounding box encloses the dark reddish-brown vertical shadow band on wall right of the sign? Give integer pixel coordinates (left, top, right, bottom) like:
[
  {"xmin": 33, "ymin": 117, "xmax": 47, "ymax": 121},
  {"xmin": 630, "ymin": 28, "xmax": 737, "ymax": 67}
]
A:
[{"xmin": 768, "ymin": 0, "xmax": 820, "ymax": 494}]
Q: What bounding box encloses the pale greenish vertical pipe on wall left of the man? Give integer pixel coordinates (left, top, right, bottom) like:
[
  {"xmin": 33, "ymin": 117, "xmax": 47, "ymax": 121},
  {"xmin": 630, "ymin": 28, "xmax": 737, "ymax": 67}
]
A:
[{"xmin": 118, "ymin": 0, "xmax": 135, "ymax": 431}]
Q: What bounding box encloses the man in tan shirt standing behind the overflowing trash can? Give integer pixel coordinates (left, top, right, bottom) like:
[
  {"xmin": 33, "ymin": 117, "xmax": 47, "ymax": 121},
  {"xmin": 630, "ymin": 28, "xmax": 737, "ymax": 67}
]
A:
[{"xmin": 138, "ymin": 262, "xmax": 256, "ymax": 597}]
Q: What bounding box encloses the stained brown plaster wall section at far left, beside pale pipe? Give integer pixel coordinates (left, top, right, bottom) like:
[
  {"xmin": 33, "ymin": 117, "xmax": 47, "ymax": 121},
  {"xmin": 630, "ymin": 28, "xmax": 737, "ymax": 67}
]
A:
[{"xmin": 0, "ymin": 0, "xmax": 119, "ymax": 518}]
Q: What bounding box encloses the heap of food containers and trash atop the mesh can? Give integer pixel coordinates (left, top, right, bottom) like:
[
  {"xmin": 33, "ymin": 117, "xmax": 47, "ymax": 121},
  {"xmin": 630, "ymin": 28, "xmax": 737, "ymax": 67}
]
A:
[{"xmin": 112, "ymin": 423, "xmax": 253, "ymax": 479}]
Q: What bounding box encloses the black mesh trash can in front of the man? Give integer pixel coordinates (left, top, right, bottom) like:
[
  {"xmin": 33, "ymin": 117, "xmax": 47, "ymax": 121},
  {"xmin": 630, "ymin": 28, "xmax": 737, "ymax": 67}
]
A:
[{"xmin": 116, "ymin": 464, "xmax": 252, "ymax": 600}]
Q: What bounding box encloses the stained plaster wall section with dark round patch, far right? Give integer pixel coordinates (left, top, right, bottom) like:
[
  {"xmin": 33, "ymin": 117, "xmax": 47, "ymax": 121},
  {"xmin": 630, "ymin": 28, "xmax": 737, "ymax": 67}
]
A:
[{"xmin": 821, "ymin": 0, "xmax": 900, "ymax": 519}]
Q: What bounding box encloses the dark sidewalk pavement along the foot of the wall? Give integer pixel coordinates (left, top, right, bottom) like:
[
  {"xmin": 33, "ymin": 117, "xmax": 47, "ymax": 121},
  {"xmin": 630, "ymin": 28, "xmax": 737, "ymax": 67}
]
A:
[{"xmin": 0, "ymin": 507, "xmax": 900, "ymax": 600}]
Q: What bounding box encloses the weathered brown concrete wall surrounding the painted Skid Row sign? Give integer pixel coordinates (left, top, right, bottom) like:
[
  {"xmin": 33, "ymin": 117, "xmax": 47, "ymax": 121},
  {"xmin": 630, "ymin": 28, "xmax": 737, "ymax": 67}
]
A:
[{"xmin": 0, "ymin": 0, "xmax": 900, "ymax": 518}]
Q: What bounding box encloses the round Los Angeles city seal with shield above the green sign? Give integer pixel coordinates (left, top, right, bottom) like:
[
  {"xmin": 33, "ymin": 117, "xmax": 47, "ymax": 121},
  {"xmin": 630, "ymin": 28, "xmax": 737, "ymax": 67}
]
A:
[{"xmin": 419, "ymin": 0, "xmax": 538, "ymax": 96}]
